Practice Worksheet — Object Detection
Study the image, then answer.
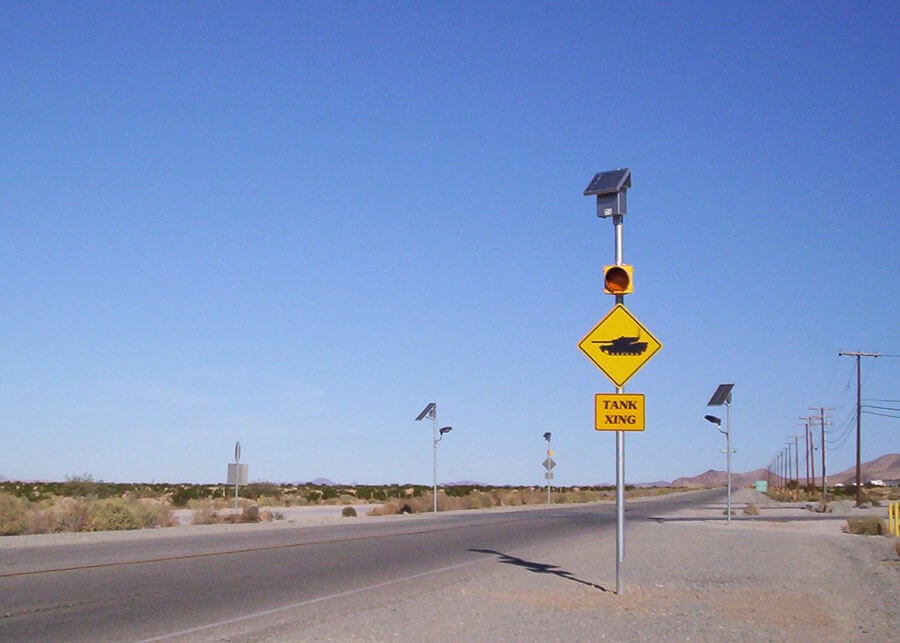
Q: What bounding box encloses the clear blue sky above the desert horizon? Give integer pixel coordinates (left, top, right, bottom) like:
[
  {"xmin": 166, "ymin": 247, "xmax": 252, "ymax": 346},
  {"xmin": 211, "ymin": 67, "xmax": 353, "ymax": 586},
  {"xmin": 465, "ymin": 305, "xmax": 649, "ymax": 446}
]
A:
[{"xmin": 0, "ymin": 2, "xmax": 900, "ymax": 485}]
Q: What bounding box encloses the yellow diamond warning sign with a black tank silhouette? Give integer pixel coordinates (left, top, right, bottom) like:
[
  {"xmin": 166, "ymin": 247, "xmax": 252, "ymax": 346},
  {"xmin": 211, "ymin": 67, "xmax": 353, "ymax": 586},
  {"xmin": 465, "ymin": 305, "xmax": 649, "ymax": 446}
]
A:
[{"xmin": 578, "ymin": 304, "xmax": 662, "ymax": 386}]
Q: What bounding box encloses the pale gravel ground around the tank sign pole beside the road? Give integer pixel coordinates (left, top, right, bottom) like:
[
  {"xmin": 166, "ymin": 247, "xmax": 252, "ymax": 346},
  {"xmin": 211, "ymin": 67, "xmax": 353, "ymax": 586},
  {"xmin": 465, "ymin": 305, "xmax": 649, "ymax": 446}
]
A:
[{"xmin": 268, "ymin": 490, "xmax": 900, "ymax": 641}]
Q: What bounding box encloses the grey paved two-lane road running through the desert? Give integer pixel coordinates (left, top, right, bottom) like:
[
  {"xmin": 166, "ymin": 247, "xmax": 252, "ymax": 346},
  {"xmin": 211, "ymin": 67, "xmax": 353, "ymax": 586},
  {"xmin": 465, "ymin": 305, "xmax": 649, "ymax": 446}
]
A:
[{"xmin": 0, "ymin": 491, "xmax": 722, "ymax": 641}]
